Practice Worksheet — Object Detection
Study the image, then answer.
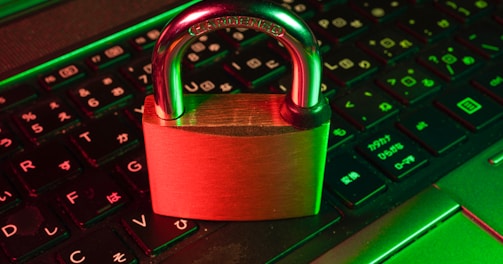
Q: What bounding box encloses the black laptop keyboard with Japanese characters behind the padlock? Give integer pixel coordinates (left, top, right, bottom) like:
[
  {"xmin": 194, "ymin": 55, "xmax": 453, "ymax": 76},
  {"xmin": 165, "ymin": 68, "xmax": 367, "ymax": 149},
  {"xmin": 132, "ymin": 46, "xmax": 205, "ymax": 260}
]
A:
[{"xmin": 0, "ymin": 0, "xmax": 503, "ymax": 263}]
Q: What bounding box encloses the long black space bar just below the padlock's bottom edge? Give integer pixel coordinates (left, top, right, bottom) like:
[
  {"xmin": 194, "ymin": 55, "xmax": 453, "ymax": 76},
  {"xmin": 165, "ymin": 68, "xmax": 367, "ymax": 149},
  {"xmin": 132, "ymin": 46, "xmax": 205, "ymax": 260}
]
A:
[{"xmin": 163, "ymin": 202, "xmax": 341, "ymax": 263}]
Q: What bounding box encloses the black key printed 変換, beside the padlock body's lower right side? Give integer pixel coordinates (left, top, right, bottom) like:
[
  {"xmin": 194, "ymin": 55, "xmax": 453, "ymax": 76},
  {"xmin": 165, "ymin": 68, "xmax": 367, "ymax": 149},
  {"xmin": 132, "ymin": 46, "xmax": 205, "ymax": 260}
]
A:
[{"xmin": 325, "ymin": 154, "xmax": 386, "ymax": 208}]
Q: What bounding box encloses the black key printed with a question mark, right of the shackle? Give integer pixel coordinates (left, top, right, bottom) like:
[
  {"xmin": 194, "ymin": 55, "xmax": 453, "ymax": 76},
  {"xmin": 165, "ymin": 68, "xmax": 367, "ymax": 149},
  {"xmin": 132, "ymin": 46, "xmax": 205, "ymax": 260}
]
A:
[{"xmin": 376, "ymin": 63, "xmax": 442, "ymax": 105}]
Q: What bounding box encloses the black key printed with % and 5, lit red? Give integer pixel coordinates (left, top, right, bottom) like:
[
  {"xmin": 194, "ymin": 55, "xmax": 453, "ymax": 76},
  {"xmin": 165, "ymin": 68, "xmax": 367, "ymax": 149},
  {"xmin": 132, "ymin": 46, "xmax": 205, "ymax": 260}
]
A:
[{"xmin": 15, "ymin": 97, "xmax": 79, "ymax": 142}]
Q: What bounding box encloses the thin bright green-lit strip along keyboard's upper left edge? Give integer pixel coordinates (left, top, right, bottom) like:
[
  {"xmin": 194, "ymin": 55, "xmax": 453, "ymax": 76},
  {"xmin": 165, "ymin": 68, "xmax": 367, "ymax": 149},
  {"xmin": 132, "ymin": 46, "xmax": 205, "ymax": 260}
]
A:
[{"xmin": 0, "ymin": 0, "xmax": 200, "ymax": 87}]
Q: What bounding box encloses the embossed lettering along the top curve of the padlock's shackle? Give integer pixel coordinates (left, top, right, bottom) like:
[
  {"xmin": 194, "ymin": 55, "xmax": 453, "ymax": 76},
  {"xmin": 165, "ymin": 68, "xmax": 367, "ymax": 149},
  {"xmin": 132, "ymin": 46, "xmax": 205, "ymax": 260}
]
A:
[{"xmin": 189, "ymin": 16, "xmax": 285, "ymax": 37}]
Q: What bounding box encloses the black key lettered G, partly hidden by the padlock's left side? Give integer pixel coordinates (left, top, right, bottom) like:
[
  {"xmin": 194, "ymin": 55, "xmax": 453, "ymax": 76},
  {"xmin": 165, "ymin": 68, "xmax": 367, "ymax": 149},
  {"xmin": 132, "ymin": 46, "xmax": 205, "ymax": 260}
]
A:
[{"xmin": 117, "ymin": 149, "xmax": 150, "ymax": 194}]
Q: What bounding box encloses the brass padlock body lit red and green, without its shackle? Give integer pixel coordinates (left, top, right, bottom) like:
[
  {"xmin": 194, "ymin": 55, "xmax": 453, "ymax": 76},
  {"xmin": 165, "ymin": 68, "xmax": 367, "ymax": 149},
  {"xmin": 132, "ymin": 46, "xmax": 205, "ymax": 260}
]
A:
[{"xmin": 143, "ymin": 94, "xmax": 330, "ymax": 220}]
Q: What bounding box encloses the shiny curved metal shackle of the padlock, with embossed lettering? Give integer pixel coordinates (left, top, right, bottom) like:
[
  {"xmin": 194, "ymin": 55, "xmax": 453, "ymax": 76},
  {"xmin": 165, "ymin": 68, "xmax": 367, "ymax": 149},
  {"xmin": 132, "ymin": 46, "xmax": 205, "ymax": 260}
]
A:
[{"xmin": 152, "ymin": 0, "xmax": 330, "ymax": 128}]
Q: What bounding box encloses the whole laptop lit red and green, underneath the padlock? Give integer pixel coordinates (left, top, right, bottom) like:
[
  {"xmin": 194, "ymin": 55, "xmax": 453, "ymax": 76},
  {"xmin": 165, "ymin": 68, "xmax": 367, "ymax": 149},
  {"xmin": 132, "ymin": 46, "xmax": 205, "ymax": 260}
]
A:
[{"xmin": 0, "ymin": 1, "xmax": 503, "ymax": 263}]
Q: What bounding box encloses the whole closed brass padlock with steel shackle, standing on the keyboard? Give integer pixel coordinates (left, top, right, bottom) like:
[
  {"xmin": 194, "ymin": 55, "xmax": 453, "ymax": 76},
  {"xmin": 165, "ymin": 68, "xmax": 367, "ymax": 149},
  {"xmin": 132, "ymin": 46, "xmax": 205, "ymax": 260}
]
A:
[{"xmin": 143, "ymin": 0, "xmax": 331, "ymax": 221}]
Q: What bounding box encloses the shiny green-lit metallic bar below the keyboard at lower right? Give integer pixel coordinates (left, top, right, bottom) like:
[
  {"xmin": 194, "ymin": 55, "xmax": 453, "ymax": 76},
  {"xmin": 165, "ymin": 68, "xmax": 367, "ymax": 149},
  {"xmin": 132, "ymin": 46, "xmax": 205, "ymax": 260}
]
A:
[{"xmin": 312, "ymin": 187, "xmax": 461, "ymax": 264}]
